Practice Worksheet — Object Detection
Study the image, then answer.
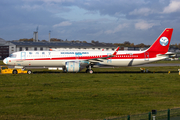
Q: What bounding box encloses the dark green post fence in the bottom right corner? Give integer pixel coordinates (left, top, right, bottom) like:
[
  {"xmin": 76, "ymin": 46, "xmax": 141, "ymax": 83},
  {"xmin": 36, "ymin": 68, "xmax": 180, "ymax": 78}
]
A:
[{"xmin": 104, "ymin": 108, "xmax": 180, "ymax": 120}]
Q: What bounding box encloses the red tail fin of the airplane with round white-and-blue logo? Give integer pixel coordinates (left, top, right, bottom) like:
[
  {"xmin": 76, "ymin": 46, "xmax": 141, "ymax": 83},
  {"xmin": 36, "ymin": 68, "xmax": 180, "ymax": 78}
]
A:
[{"xmin": 147, "ymin": 28, "xmax": 173, "ymax": 54}]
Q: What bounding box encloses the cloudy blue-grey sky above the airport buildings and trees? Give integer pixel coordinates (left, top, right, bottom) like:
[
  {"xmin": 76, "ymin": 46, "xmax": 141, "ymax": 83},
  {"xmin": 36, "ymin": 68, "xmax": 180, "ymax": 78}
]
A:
[{"xmin": 0, "ymin": 0, "xmax": 180, "ymax": 45}]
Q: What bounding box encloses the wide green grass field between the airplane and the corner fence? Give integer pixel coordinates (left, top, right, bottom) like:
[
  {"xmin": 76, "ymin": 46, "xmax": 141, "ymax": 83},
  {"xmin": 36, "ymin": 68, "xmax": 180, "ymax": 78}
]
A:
[{"xmin": 0, "ymin": 67, "xmax": 180, "ymax": 120}]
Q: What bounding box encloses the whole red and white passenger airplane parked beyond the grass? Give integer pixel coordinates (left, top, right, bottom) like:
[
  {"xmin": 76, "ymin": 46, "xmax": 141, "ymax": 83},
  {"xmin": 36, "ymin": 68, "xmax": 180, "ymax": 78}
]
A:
[{"xmin": 3, "ymin": 28, "xmax": 173, "ymax": 74}]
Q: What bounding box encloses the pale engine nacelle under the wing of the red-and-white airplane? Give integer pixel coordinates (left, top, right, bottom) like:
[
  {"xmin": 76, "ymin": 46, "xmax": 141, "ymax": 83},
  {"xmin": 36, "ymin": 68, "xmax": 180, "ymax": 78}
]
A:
[{"xmin": 65, "ymin": 61, "xmax": 80, "ymax": 72}]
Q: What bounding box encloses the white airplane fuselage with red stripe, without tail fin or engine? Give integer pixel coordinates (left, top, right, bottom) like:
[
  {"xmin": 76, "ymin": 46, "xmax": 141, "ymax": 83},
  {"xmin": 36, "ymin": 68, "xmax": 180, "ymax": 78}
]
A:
[{"xmin": 4, "ymin": 50, "xmax": 166, "ymax": 67}]
